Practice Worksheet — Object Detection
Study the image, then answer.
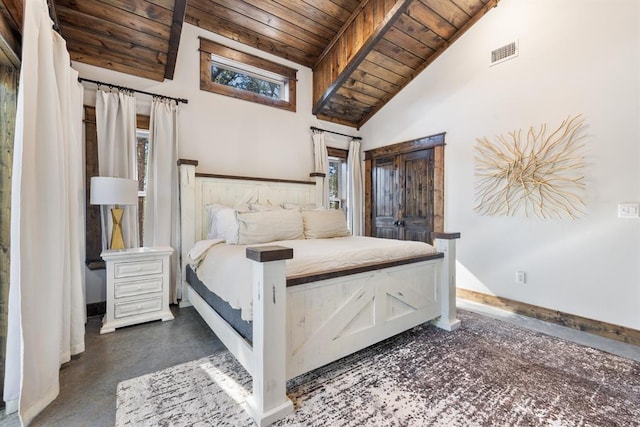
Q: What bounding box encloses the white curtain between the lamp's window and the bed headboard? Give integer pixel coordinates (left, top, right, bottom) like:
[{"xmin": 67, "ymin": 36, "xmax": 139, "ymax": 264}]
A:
[{"xmin": 142, "ymin": 99, "xmax": 182, "ymax": 303}]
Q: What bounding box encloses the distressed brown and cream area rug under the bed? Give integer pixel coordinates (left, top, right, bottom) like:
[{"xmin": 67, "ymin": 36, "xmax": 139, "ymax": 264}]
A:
[{"xmin": 116, "ymin": 311, "xmax": 640, "ymax": 427}]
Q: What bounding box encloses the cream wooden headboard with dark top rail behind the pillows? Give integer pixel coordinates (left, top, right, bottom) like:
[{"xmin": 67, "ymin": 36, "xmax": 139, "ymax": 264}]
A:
[{"xmin": 178, "ymin": 159, "xmax": 322, "ymax": 306}]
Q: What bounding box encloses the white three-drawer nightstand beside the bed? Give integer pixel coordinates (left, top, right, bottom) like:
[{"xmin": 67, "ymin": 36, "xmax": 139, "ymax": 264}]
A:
[{"xmin": 100, "ymin": 246, "xmax": 173, "ymax": 334}]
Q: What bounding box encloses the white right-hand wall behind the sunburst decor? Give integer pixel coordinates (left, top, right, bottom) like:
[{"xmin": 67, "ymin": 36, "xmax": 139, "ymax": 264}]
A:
[{"xmin": 362, "ymin": 0, "xmax": 640, "ymax": 329}]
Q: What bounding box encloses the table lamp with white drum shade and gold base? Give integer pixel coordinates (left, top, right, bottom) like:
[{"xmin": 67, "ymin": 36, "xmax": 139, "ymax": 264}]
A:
[{"xmin": 90, "ymin": 176, "xmax": 138, "ymax": 250}]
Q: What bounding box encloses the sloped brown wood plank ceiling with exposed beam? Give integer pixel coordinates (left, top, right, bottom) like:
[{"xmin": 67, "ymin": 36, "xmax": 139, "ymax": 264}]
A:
[{"xmin": 52, "ymin": 0, "xmax": 498, "ymax": 128}]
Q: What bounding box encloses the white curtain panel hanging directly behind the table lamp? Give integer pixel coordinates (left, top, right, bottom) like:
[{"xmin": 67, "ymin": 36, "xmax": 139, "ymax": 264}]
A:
[{"xmin": 96, "ymin": 88, "xmax": 139, "ymax": 249}]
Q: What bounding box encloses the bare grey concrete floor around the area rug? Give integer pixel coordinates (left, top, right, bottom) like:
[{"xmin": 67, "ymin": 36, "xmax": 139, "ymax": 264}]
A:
[{"xmin": 0, "ymin": 300, "xmax": 640, "ymax": 427}]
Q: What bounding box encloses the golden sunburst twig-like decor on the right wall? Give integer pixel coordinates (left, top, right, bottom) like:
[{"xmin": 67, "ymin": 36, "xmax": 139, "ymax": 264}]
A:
[{"xmin": 474, "ymin": 115, "xmax": 585, "ymax": 219}]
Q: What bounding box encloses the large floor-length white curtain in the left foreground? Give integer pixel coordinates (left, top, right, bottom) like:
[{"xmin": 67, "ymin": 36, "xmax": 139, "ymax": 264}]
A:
[{"xmin": 4, "ymin": 0, "xmax": 86, "ymax": 424}]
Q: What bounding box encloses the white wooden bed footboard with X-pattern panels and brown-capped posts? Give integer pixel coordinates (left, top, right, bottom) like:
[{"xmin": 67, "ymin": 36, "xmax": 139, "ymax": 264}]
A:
[{"xmin": 247, "ymin": 237, "xmax": 460, "ymax": 426}]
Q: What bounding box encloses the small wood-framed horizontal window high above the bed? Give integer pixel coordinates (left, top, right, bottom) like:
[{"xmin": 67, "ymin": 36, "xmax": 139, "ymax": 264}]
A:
[{"xmin": 200, "ymin": 39, "xmax": 297, "ymax": 111}]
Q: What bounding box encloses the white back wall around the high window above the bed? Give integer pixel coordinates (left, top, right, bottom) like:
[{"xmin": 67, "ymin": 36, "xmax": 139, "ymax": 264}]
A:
[{"xmin": 73, "ymin": 24, "xmax": 357, "ymax": 303}]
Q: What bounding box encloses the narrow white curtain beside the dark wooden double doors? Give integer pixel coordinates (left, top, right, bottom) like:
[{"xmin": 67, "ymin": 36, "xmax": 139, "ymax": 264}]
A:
[{"xmin": 347, "ymin": 139, "xmax": 364, "ymax": 236}]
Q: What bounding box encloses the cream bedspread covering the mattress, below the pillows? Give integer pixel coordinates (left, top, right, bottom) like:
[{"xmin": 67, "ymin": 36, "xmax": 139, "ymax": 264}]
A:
[{"xmin": 189, "ymin": 236, "xmax": 435, "ymax": 320}]
